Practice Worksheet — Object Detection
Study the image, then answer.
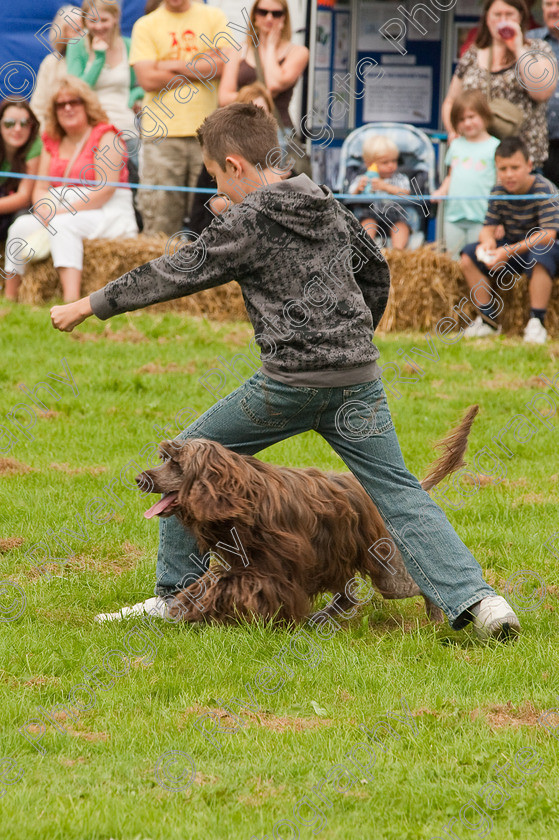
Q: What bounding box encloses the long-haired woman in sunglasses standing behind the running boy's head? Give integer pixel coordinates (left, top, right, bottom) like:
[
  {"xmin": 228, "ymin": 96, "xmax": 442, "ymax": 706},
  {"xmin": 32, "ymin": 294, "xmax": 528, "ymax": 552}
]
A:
[{"xmin": 219, "ymin": 0, "xmax": 309, "ymax": 129}]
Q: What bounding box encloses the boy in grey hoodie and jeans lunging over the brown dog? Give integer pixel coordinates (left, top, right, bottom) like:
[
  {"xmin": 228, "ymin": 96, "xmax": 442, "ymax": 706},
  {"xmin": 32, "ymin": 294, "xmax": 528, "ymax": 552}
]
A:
[{"xmin": 51, "ymin": 103, "xmax": 520, "ymax": 638}]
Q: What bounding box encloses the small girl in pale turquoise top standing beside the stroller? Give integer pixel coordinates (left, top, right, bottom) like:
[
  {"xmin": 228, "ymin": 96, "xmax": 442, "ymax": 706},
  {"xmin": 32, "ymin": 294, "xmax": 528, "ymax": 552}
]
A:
[{"xmin": 433, "ymin": 90, "xmax": 499, "ymax": 260}]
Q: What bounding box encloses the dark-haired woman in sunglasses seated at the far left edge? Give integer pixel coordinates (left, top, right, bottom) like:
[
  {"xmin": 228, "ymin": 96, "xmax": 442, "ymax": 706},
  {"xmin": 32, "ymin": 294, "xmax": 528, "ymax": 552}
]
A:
[{"xmin": 0, "ymin": 99, "xmax": 41, "ymax": 242}]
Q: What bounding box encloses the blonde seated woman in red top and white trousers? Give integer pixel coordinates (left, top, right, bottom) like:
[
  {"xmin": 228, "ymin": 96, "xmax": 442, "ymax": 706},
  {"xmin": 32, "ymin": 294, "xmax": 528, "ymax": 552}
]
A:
[{"xmin": 5, "ymin": 77, "xmax": 138, "ymax": 302}]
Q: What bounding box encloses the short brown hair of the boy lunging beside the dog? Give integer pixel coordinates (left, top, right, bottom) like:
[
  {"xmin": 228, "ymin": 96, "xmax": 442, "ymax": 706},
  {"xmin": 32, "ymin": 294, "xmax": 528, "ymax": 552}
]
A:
[{"xmin": 196, "ymin": 102, "xmax": 278, "ymax": 170}]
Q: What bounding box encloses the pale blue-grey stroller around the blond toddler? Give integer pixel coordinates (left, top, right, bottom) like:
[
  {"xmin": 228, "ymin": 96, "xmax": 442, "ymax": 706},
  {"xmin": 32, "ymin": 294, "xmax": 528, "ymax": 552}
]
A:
[{"xmin": 336, "ymin": 122, "xmax": 437, "ymax": 249}]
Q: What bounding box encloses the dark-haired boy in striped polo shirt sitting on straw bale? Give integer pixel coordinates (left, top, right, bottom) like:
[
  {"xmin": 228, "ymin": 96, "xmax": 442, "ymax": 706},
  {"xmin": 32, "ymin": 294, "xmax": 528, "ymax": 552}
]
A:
[{"xmin": 460, "ymin": 137, "xmax": 559, "ymax": 344}]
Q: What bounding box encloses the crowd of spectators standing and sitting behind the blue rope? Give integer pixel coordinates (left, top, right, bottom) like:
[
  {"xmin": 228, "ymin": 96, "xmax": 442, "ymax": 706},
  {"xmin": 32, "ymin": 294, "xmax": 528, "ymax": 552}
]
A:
[{"xmin": 0, "ymin": 0, "xmax": 559, "ymax": 343}]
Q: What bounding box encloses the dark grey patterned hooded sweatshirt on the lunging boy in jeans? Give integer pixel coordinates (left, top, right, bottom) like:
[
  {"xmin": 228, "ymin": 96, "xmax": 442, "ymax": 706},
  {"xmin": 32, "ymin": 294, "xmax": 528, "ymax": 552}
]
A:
[{"xmin": 90, "ymin": 175, "xmax": 390, "ymax": 387}]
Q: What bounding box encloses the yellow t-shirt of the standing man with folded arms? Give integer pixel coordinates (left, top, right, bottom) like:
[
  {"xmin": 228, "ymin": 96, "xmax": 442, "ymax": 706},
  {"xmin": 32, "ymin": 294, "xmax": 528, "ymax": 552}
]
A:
[{"xmin": 129, "ymin": 2, "xmax": 231, "ymax": 139}]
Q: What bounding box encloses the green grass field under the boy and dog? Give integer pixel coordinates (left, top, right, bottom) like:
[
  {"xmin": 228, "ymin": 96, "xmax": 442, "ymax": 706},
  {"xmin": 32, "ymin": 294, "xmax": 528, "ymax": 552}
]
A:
[{"xmin": 0, "ymin": 304, "xmax": 559, "ymax": 840}]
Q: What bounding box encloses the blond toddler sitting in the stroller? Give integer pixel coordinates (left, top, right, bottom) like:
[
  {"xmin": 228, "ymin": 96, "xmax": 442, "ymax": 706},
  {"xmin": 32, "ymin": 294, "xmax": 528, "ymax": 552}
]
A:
[{"xmin": 348, "ymin": 134, "xmax": 419, "ymax": 251}]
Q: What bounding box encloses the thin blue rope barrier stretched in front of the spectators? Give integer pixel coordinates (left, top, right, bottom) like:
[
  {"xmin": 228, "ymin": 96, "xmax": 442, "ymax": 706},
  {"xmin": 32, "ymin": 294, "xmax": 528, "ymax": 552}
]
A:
[{"xmin": 0, "ymin": 172, "xmax": 559, "ymax": 204}]
